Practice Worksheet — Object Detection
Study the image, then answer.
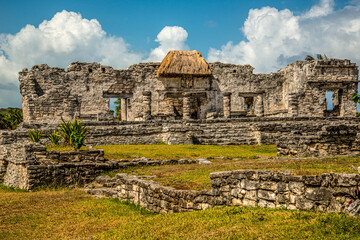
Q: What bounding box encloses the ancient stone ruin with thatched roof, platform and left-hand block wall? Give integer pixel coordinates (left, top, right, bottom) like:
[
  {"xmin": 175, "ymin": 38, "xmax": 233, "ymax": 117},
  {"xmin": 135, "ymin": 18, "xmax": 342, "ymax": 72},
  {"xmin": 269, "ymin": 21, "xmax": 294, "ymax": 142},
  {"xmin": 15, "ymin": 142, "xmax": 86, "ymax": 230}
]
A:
[{"xmin": 0, "ymin": 51, "xmax": 360, "ymax": 195}]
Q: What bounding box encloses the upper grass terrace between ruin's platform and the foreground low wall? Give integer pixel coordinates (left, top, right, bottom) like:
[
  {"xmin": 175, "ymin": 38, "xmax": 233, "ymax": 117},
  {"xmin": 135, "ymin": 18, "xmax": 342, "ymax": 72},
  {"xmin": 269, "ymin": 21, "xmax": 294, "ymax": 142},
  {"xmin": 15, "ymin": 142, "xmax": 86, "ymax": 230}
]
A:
[{"xmin": 76, "ymin": 145, "xmax": 360, "ymax": 190}]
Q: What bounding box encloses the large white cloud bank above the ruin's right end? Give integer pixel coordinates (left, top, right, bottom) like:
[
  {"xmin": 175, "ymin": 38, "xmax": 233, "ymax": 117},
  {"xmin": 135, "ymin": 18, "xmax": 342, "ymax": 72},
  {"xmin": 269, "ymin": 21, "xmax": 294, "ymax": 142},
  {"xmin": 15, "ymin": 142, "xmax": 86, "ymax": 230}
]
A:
[{"xmin": 207, "ymin": 0, "xmax": 360, "ymax": 72}]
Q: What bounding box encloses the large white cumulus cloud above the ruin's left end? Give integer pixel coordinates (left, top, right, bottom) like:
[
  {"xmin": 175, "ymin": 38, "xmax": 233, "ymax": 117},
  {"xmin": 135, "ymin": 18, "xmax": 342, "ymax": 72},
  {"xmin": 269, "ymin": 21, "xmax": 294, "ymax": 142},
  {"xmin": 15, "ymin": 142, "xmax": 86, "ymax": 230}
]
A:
[{"xmin": 0, "ymin": 10, "xmax": 142, "ymax": 107}]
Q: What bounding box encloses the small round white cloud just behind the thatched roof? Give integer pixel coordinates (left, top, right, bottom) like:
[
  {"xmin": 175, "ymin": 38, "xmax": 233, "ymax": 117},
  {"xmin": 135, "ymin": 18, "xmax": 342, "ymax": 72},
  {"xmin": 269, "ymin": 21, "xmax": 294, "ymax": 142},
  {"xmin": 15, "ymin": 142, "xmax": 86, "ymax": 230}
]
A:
[{"xmin": 146, "ymin": 26, "xmax": 189, "ymax": 62}]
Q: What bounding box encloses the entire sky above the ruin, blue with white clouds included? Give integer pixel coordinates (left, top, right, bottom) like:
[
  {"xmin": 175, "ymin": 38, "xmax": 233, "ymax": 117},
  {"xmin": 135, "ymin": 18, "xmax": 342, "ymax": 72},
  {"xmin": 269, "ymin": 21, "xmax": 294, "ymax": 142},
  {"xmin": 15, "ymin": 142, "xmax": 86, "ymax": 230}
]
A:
[{"xmin": 0, "ymin": 0, "xmax": 360, "ymax": 107}]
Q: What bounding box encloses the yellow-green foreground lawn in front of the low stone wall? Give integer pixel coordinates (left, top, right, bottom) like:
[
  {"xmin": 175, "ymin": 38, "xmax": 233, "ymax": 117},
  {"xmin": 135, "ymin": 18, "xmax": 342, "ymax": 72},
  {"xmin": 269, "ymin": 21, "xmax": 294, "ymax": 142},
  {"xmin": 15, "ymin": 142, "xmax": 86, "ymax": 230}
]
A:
[{"xmin": 0, "ymin": 185, "xmax": 360, "ymax": 239}]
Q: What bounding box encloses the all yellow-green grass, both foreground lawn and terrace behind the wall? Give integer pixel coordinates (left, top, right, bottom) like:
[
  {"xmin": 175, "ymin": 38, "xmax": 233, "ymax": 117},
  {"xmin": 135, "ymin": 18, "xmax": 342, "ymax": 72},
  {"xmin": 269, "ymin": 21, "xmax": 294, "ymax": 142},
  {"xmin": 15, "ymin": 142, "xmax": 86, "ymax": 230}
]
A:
[{"xmin": 4, "ymin": 145, "xmax": 360, "ymax": 239}]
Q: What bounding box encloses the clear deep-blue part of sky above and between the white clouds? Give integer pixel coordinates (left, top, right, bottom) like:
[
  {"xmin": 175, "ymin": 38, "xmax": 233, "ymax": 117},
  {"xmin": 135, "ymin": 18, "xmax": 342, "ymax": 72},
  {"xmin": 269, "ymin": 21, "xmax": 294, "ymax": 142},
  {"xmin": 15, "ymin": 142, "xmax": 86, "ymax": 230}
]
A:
[{"xmin": 0, "ymin": 0, "xmax": 349, "ymax": 57}]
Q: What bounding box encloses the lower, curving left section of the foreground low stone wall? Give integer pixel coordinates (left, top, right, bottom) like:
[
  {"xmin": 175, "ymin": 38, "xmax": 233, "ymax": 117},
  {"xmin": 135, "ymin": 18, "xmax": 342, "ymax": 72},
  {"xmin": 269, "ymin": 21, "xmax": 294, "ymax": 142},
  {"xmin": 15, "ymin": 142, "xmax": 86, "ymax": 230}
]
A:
[{"xmin": 85, "ymin": 174, "xmax": 214, "ymax": 213}]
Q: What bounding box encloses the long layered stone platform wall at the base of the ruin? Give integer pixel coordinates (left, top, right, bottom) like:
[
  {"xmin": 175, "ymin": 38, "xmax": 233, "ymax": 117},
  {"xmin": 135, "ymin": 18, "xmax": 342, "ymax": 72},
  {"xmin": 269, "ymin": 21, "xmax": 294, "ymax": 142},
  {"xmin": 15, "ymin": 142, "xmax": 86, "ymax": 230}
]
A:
[{"xmin": 0, "ymin": 118, "xmax": 360, "ymax": 156}]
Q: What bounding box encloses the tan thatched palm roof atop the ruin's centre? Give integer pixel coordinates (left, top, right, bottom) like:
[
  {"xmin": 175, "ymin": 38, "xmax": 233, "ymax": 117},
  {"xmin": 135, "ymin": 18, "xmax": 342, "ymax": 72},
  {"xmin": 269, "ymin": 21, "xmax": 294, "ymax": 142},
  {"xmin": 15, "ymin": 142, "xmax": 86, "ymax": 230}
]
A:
[{"xmin": 157, "ymin": 50, "xmax": 211, "ymax": 77}]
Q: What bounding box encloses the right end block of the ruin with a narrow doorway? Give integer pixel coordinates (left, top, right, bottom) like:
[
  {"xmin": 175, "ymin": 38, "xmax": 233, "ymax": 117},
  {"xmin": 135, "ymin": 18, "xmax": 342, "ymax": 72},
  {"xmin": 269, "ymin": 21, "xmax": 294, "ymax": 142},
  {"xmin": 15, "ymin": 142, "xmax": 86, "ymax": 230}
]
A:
[{"xmin": 279, "ymin": 59, "xmax": 359, "ymax": 117}]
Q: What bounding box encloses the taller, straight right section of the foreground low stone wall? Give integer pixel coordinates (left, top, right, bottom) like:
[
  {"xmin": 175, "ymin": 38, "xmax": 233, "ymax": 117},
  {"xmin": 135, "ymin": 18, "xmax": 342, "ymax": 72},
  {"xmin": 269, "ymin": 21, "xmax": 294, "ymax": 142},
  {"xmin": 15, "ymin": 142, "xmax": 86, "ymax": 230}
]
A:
[{"xmin": 210, "ymin": 170, "xmax": 360, "ymax": 212}]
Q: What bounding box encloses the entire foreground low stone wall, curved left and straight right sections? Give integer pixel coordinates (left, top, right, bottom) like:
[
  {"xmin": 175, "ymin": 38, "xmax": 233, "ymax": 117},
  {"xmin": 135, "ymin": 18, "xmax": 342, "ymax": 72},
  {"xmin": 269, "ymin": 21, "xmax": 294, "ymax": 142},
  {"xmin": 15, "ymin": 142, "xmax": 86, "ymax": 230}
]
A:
[{"xmin": 85, "ymin": 170, "xmax": 360, "ymax": 213}]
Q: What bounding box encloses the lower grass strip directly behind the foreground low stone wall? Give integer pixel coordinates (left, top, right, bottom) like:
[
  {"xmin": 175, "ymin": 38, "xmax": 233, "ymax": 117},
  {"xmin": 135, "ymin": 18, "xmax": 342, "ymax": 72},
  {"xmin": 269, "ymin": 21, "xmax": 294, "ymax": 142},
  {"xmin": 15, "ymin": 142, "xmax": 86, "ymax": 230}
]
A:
[{"xmin": 109, "ymin": 158, "xmax": 360, "ymax": 190}]
